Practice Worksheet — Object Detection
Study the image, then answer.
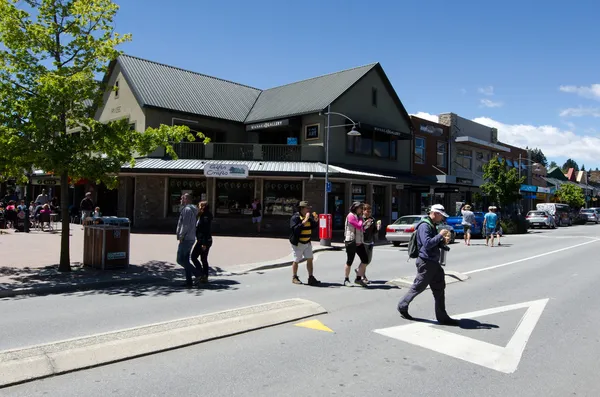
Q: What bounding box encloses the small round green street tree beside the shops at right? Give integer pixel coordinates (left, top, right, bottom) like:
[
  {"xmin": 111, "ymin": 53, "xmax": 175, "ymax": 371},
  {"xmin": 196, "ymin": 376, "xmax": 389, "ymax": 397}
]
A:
[{"xmin": 481, "ymin": 157, "xmax": 527, "ymax": 207}]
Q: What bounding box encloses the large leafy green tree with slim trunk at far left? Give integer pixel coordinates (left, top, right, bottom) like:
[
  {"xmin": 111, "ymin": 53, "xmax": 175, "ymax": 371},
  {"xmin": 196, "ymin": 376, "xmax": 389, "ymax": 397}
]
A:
[{"xmin": 0, "ymin": 0, "xmax": 199, "ymax": 271}]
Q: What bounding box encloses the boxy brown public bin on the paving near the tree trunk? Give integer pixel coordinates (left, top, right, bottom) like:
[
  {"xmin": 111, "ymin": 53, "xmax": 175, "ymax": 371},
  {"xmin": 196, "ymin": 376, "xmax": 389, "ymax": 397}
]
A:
[{"xmin": 83, "ymin": 216, "xmax": 130, "ymax": 270}]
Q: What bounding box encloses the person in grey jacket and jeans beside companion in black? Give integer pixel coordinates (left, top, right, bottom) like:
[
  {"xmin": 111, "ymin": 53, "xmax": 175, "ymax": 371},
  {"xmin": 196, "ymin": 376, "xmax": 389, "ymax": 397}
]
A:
[{"xmin": 177, "ymin": 193, "xmax": 198, "ymax": 288}]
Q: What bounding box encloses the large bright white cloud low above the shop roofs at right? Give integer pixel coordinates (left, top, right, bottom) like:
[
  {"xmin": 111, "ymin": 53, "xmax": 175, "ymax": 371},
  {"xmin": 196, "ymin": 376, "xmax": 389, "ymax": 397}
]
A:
[{"xmin": 473, "ymin": 117, "xmax": 600, "ymax": 164}]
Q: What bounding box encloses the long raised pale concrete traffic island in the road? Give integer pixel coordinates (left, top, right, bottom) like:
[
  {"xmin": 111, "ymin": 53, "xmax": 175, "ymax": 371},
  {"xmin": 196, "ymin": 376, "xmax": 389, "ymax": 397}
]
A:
[{"xmin": 0, "ymin": 299, "xmax": 327, "ymax": 388}]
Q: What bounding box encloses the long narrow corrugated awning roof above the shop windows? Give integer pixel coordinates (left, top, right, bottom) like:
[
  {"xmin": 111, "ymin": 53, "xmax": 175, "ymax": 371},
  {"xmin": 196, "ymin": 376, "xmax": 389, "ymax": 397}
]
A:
[{"xmin": 122, "ymin": 158, "xmax": 395, "ymax": 180}]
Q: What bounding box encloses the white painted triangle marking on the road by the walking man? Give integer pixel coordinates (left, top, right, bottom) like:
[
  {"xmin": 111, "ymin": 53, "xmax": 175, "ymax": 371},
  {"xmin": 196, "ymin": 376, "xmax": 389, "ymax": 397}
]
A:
[{"xmin": 374, "ymin": 299, "xmax": 549, "ymax": 374}]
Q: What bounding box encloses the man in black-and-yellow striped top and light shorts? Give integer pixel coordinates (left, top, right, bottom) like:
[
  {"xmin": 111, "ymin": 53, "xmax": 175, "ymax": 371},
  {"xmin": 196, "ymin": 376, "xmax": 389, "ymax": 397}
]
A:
[{"xmin": 290, "ymin": 201, "xmax": 321, "ymax": 286}]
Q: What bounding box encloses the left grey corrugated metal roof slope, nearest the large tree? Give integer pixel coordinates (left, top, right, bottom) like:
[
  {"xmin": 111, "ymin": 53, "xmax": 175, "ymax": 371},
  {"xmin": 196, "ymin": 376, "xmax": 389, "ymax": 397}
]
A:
[{"xmin": 118, "ymin": 55, "xmax": 261, "ymax": 122}]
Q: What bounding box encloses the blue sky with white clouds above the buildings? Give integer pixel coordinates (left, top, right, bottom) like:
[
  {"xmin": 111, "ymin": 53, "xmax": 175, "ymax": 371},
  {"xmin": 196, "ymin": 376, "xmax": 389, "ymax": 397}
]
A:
[{"xmin": 116, "ymin": 0, "xmax": 600, "ymax": 169}]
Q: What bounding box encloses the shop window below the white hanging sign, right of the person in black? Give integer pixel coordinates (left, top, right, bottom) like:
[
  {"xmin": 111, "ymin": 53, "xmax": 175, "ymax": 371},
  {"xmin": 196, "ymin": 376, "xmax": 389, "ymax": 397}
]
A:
[{"xmin": 215, "ymin": 179, "xmax": 254, "ymax": 216}]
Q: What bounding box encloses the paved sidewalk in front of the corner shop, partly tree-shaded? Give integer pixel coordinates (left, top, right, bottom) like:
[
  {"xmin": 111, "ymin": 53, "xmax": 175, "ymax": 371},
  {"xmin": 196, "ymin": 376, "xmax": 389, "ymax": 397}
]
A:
[{"xmin": 0, "ymin": 225, "xmax": 354, "ymax": 298}]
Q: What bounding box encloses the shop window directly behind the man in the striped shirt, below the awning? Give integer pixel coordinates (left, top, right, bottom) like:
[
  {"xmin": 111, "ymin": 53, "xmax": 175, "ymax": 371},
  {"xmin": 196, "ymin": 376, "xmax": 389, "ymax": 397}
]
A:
[{"xmin": 264, "ymin": 181, "xmax": 302, "ymax": 216}]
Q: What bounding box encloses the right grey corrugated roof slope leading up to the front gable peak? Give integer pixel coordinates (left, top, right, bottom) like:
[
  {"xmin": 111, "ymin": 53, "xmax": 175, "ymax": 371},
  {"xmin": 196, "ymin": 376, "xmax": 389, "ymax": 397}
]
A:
[{"xmin": 246, "ymin": 63, "xmax": 377, "ymax": 123}]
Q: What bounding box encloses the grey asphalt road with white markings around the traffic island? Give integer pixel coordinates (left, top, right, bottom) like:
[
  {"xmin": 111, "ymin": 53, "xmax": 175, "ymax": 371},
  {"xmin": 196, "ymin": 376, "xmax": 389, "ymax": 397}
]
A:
[{"xmin": 0, "ymin": 225, "xmax": 600, "ymax": 397}]
